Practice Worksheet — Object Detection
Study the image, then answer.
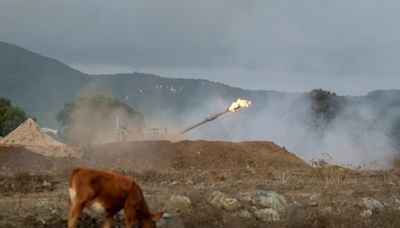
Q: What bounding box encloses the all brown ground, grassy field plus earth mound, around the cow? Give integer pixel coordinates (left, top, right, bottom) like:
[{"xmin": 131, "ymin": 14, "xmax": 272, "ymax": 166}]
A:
[{"xmin": 0, "ymin": 141, "xmax": 400, "ymax": 227}]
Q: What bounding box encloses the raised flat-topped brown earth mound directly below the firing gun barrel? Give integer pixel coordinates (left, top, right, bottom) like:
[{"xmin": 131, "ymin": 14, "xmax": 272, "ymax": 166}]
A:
[{"xmin": 87, "ymin": 141, "xmax": 308, "ymax": 170}]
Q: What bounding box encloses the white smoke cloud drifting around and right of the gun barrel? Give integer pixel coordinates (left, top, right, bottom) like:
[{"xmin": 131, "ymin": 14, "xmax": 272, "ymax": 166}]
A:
[{"xmin": 158, "ymin": 91, "xmax": 396, "ymax": 168}]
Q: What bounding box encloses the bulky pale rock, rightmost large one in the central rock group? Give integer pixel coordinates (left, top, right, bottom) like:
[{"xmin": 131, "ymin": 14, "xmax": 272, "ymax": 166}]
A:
[{"xmin": 253, "ymin": 192, "xmax": 286, "ymax": 212}]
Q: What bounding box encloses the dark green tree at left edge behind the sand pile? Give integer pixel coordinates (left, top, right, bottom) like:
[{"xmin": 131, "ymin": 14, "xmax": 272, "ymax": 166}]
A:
[{"xmin": 0, "ymin": 97, "xmax": 27, "ymax": 136}]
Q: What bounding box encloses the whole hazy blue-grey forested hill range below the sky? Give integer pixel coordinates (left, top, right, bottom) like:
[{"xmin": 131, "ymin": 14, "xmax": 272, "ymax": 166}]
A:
[{"xmin": 0, "ymin": 42, "xmax": 400, "ymax": 137}]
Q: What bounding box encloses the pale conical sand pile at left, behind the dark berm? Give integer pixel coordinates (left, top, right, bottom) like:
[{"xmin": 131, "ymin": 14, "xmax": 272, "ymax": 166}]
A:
[{"xmin": 0, "ymin": 118, "xmax": 82, "ymax": 157}]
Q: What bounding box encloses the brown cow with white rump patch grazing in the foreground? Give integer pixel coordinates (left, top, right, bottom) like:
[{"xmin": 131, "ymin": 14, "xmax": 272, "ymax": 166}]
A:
[{"xmin": 68, "ymin": 167, "xmax": 163, "ymax": 228}]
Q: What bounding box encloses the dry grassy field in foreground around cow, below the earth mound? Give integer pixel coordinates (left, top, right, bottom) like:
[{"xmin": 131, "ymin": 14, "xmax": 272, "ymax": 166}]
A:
[{"xmin": 0, "ymin": 142, "xmax": 400, "ymax": 228}]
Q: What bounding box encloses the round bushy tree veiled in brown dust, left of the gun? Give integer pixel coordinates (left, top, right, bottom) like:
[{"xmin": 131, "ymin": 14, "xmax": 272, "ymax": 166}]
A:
[{"xmin": 56, "ymin": 96, "xmax": 144, "ymax": 143}]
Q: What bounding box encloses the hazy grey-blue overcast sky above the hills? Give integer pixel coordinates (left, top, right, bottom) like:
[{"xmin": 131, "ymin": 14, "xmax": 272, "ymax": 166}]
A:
[{"xmin": 0, "ymin": 0, "xmax": 400, "ymax": 94}]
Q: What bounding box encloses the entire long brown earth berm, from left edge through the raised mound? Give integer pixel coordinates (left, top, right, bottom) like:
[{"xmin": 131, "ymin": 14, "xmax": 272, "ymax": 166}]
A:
[{"xmin": 0, "ymin": 141, "xmax": 309, "ymax": 171}]
